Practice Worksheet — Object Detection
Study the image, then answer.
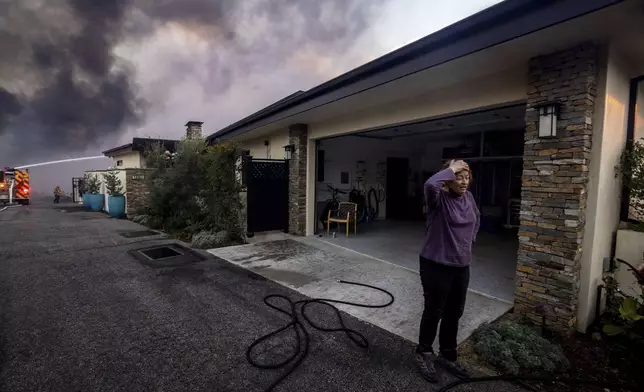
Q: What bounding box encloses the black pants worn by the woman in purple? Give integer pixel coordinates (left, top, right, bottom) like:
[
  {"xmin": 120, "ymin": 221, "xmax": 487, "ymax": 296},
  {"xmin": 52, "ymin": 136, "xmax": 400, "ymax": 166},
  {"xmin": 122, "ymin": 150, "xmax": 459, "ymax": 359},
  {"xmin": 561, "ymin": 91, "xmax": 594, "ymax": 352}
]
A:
[{"xmin": 418, "ymin": 257, "xmax": 470, "ymax": 361}]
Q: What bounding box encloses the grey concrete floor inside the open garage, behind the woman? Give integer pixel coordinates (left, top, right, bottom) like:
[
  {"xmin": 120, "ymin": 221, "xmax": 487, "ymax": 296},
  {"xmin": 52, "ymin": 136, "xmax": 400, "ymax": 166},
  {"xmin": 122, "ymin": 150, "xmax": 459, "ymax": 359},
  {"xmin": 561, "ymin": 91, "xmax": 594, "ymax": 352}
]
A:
[{"xmin": 319, "ymin": 220, "xmax": 518, "ymax": 301}]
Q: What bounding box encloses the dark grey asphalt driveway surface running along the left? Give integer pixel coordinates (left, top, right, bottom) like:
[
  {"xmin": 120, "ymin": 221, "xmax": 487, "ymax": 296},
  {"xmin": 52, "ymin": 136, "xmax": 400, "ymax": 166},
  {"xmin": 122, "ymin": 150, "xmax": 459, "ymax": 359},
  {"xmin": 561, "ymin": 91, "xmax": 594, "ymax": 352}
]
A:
[{"xmin": 0, "ymin": 204, "xmax": 520, "ymax": 392}]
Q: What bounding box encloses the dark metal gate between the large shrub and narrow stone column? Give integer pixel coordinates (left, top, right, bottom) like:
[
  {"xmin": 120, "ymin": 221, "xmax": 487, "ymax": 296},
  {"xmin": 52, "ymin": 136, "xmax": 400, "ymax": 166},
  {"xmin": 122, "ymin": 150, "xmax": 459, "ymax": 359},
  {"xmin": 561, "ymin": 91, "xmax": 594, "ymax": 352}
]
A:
[{"xmin": 246, "ymin": 158, "xmax": 288, "ymax": 234}]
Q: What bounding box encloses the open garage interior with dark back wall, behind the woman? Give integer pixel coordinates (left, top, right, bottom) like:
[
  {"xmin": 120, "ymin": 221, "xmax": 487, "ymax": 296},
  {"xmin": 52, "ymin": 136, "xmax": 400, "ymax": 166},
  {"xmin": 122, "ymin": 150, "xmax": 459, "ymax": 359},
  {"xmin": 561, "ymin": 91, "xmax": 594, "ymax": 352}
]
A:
[{"xmin": 316, "ymin": 105, "xmax": 525, "ymax": 301}]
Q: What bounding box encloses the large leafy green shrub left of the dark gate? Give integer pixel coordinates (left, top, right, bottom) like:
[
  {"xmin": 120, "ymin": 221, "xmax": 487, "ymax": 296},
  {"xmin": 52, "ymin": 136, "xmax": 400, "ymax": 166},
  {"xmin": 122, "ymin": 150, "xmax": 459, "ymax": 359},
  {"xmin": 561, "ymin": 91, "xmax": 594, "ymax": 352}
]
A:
[{"xmin": 144, "ymin": 138, "xmax": 243, "ymax": 240}]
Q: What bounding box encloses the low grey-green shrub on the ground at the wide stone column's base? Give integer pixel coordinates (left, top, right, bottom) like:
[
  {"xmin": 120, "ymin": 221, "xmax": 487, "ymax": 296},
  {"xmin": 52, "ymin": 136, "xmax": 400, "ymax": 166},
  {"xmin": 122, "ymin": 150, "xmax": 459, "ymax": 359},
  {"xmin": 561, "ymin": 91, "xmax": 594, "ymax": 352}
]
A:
[{"xmin": 474, "ymin": 321, "xmax": 570, "ymax": 374}]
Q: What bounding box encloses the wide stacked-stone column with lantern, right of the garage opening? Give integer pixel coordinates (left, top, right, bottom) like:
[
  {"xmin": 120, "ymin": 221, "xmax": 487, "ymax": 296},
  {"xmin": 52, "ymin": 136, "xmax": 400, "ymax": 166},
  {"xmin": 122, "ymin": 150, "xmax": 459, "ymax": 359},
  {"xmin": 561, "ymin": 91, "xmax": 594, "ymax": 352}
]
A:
[{"xmin": 515, "ymin": 44, "xmax": 598, "ymax": 332}]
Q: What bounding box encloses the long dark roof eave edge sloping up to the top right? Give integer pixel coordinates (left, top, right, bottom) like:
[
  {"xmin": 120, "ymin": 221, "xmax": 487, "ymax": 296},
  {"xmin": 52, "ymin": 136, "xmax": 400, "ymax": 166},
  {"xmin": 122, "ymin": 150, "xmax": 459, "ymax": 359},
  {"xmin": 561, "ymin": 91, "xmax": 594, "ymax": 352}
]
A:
[{"xmin": 207, "ymin": 0, "xmax": 624, "ymax": 142}]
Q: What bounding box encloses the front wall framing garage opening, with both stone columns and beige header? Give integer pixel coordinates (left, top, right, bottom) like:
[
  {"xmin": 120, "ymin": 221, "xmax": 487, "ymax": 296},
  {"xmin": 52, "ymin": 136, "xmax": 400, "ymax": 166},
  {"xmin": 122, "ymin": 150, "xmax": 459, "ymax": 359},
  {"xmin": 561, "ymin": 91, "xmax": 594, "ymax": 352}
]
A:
[{"xmin": 224, "ymin": 44, "xmax": 634, "ymax": 331}]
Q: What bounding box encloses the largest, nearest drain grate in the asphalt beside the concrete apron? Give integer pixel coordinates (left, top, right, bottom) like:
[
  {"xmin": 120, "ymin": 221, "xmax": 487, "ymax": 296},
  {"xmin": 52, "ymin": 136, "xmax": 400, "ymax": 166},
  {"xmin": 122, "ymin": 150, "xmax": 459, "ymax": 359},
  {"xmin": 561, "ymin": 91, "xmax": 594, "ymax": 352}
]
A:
[{"xmin": 128, "ymin": 243, "xmax": 206, "ymax": 268}]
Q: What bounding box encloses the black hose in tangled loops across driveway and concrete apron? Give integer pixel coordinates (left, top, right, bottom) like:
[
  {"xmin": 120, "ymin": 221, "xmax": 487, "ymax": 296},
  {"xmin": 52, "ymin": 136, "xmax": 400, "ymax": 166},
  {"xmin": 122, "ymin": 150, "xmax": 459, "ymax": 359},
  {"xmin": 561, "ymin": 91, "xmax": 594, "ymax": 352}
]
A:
[{"xmin": 246, "ymin": 280, "xmax": 394, "ymax": 392}]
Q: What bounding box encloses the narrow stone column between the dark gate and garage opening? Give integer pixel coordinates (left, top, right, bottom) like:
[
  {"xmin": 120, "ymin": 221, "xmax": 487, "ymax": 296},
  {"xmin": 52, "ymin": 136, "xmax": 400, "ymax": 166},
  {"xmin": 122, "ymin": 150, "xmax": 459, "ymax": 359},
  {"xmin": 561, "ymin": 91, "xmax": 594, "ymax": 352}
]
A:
[{"xmin": 288, "ymin": 124, "xmax": 309, "ymax": 235}]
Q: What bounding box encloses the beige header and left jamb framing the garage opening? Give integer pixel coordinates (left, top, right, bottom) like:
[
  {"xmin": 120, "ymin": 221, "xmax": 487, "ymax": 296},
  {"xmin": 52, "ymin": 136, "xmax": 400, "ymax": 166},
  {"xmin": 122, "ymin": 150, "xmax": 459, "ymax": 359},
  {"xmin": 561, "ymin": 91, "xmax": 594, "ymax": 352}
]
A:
[{"xmin": 306, "ymin": 64, "xmax": 528, "ymax": 235}]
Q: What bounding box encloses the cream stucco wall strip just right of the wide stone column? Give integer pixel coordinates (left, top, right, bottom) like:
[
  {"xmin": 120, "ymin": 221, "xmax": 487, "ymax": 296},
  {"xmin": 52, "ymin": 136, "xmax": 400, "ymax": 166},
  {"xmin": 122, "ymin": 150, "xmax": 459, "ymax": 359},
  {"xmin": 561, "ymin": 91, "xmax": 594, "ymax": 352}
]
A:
[{"xmin": 577, "ymin": 48, "xmax": 631, "ymax": 331}]
